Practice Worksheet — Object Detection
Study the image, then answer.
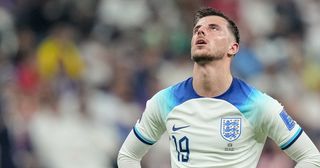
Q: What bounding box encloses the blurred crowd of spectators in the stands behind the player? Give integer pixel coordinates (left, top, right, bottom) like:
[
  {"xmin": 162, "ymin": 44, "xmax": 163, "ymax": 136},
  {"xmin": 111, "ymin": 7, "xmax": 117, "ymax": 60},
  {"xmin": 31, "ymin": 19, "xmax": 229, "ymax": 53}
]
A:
[{"xmin": 0, "ymin": 0, "xmax": 320, "ymax": 168}]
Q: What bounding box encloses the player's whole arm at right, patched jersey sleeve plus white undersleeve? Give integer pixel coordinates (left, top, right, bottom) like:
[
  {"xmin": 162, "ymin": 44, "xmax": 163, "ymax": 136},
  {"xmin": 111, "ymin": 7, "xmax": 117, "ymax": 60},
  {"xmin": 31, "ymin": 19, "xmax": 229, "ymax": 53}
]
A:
[{"xmin": 260, "ymin": 94, "xmax": 320, "ymax": 168}]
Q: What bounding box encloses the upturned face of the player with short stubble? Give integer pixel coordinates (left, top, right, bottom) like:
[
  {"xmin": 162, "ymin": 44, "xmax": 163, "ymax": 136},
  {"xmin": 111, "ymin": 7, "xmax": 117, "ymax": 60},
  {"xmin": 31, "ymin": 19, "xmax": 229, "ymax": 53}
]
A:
[{"xmin": 191, "ymin": 16, "xmax": 234, "ymax": 62}]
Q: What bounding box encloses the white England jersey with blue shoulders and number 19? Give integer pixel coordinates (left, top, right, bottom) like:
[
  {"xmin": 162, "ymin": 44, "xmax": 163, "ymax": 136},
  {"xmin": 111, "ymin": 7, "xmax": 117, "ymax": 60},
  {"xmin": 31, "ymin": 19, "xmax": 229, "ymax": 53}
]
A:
[{"xmin": 133, "ymin": 78, "xmax": 302, "ymax": 168}]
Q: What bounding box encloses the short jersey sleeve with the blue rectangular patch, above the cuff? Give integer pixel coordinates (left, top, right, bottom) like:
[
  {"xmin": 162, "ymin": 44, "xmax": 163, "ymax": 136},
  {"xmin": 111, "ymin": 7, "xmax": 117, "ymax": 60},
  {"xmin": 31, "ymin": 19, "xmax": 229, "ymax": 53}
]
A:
[{"xmin": 259, "ymin": 93, "xmax": 303, "ymax": 150}]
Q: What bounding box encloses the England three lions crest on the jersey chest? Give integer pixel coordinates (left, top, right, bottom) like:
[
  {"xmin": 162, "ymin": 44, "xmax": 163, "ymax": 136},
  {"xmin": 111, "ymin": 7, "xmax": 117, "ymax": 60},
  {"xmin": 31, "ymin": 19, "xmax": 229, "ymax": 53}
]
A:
[{"xmin": 220, "ymin": 118, "xmax": 241, "ymax": 142}]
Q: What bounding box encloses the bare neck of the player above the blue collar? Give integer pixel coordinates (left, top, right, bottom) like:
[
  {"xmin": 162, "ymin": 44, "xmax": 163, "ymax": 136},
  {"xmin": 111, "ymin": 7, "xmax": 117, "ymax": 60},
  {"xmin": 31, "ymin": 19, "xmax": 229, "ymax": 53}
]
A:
[{"xmin": 192, "ymin": 61, "xmax": 232, "ymax": 97}]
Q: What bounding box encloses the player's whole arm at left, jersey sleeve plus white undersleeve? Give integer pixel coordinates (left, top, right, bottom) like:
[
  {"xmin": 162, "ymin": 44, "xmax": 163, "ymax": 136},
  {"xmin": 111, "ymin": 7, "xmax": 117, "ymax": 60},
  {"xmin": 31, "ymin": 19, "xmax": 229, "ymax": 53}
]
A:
[{"xmin": 118, "ymin": 90, "xmax": 166, "ymax": 168}]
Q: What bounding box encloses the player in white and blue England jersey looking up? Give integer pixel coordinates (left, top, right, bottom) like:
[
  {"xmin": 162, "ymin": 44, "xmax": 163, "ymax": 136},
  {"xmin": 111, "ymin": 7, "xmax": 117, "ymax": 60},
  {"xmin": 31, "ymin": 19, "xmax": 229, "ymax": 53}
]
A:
[{"xmin": 118, "ymin": 8, "xmax": 320, "ymax": 168}]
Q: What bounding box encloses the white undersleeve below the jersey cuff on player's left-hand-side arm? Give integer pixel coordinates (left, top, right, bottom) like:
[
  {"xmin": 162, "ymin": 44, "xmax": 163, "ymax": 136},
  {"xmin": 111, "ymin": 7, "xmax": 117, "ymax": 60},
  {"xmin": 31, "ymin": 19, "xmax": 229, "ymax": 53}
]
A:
[{"xmin": 118, "ymin": 130, "xmax": 151, "ymax": 168}]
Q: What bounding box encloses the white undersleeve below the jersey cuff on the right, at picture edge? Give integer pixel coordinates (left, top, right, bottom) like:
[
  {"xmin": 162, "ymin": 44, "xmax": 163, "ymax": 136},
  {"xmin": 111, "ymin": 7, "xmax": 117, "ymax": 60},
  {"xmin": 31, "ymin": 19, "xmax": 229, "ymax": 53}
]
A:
[{"xmin": 284, "ymin": 132, "xmax": 320, "ymax": 168}]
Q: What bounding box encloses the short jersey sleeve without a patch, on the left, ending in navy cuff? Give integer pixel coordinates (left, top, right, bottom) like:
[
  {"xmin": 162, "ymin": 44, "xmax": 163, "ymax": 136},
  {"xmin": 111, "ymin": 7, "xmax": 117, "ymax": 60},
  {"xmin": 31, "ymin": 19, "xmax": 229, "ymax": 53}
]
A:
[{"xmin": 133, "ymin": 91, "xmax": 166, "ymax": 145}]
